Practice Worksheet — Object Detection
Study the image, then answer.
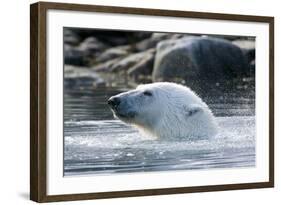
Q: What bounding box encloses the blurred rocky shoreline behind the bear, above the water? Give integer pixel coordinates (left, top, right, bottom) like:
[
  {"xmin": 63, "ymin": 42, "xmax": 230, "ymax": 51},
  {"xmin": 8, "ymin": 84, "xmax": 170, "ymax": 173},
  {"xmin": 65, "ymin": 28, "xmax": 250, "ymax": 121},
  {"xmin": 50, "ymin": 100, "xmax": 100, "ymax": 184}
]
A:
[{"xmin": 64, "ymin": 28, "xmax": 255, "ymax": 89}]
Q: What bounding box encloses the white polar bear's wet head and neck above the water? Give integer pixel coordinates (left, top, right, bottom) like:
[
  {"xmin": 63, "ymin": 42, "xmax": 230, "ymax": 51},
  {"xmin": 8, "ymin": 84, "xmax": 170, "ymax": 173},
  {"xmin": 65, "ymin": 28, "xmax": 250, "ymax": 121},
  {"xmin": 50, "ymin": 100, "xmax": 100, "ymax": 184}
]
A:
[{"xmin": 108, "ymin": 82, "xmax": 217, "ymax": 139}]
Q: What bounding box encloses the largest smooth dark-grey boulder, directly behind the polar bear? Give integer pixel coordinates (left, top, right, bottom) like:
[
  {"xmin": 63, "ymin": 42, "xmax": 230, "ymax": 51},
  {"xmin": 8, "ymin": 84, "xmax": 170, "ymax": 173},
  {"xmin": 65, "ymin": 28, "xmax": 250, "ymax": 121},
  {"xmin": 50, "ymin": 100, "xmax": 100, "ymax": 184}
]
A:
[{"xmin": 152, "ymin": 37, "xmax": 249, "ymax": 84}]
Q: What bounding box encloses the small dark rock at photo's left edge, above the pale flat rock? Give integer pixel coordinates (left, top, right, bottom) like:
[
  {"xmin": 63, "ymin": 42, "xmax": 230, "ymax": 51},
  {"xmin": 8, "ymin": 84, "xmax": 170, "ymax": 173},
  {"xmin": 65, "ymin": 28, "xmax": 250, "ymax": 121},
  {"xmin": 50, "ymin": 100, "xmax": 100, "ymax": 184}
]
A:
[{"xmin": 64, "ymin": 44, "xmax": 86, "ymax": 66}]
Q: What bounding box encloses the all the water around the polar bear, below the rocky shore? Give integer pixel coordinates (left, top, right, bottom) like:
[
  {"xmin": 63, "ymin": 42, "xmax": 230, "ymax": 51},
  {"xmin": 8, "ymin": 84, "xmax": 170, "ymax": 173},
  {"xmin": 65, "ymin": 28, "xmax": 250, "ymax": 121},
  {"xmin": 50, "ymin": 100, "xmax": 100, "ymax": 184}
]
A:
[{"xmin": 64, "ymin": 82, "xmax": 255, "ymax": 176}]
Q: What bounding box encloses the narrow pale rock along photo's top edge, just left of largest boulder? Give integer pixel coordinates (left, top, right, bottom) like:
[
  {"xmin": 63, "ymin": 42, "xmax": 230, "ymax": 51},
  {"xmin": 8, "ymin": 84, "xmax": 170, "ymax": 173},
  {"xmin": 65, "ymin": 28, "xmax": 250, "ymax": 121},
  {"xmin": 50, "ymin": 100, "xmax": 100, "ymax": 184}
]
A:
[{"xmin": 135, "ymin": 33, "xmax": 184, "ymax": 51}]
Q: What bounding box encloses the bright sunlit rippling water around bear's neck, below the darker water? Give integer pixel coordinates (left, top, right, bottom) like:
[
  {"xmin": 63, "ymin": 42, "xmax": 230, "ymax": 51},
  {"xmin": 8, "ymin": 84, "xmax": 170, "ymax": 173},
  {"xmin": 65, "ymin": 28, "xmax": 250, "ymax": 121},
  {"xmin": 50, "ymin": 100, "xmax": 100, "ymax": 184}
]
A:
[{"xmin": 64, "ymin": 116, "xmax": 255, "ymax": 175}]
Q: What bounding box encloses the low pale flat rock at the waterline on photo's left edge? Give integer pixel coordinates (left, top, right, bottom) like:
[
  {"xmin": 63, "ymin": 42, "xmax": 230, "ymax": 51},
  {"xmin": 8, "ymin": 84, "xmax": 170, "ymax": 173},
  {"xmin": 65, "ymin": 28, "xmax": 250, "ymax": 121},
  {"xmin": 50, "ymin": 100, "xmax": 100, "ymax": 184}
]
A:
[{"xmin": 64, "ymin": 65, "xmax": 106, "ymax": 88}]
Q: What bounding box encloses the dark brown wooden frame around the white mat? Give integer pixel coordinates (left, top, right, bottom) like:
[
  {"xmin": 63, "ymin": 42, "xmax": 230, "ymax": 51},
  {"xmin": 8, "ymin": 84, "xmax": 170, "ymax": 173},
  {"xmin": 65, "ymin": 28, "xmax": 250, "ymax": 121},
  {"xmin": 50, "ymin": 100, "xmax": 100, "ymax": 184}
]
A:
[{"xmin": 30, "ymin": 2, "xmax": 274, "ymax": 202}]
